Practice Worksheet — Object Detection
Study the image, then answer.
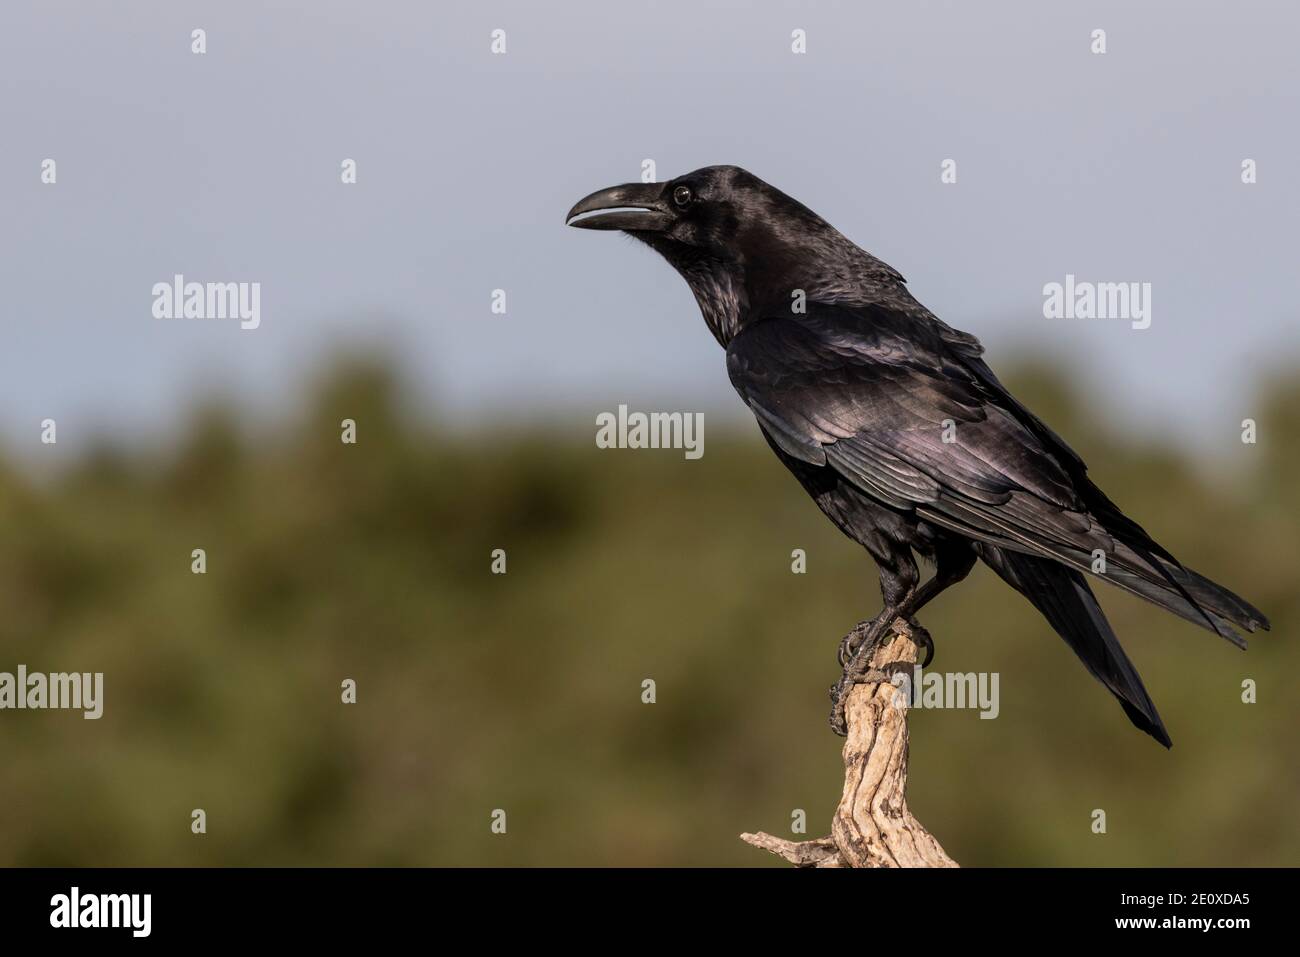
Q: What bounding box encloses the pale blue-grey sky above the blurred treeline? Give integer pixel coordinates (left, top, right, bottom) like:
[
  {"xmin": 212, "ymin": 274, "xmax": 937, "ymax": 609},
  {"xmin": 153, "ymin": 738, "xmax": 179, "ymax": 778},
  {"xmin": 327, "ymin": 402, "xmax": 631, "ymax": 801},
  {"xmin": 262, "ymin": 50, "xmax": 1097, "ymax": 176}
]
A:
[{"xmin": 0, "ymin": 0, "xmax": 1300, "ymax": 458}]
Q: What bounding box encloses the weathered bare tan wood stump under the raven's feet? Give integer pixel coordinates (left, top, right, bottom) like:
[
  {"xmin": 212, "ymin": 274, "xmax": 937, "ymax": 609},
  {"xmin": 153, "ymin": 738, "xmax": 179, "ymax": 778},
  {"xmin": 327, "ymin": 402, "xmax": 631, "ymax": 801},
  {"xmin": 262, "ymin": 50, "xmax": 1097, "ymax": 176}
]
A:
[{"xmin": 740, "ymin": 619, "xmax": 957, "ymax": 867}]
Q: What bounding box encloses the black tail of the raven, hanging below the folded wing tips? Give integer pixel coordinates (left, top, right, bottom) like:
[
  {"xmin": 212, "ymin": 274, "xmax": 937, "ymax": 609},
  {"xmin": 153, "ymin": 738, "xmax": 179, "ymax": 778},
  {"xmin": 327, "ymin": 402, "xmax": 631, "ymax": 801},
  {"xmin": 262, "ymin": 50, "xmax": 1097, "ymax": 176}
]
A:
[{"xmin": 980, "ymin": 545, "xmax": 1173, "ymax": 748}]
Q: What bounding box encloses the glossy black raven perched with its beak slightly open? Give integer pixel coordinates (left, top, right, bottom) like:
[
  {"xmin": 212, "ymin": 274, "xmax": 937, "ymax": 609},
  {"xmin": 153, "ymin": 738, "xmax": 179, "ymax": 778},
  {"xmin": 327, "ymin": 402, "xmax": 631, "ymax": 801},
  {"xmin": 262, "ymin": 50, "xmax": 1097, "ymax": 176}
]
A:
[{"xmin": 566, "ymin": 166, "xmax": 1269, "ymax": 748}]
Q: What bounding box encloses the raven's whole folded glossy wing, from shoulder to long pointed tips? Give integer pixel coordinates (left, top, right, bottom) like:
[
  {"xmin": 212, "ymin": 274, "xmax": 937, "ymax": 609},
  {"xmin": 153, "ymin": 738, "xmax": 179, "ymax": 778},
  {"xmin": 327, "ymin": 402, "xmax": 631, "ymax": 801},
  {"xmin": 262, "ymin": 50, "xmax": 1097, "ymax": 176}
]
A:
[{"xmin": 727, "ymin": 303, "xmax": 1262, "ymax": 646}]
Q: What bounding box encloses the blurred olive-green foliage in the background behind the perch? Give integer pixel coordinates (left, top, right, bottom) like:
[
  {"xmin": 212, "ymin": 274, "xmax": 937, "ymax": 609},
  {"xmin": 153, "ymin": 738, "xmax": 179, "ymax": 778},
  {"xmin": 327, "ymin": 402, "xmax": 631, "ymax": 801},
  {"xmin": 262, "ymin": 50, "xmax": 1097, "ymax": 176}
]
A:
[{"xmin": 0, "ymin": 361, "xmax": 1300, "ymax": 866}]
